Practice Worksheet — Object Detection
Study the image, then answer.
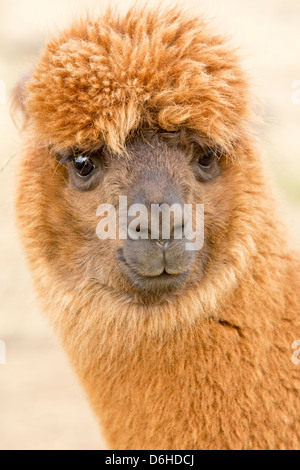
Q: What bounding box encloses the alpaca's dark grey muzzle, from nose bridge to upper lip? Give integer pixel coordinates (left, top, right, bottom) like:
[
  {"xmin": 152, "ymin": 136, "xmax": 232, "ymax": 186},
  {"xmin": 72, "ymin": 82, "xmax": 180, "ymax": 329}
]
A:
[{"xmin": 122, "ymin": 173, "xmax": 194, "ymax": 283}]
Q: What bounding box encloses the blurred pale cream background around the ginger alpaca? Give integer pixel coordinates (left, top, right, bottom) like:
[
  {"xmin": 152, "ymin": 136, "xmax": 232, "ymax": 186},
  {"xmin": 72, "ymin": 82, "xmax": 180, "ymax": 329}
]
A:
[{"xmin": 0, "ymin": 0, "xmax": 300, "ymax": 450}]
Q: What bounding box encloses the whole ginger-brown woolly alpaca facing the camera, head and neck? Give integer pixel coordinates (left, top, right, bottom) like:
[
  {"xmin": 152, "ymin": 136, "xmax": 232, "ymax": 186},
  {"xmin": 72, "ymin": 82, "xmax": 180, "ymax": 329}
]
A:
[{"xmin": 16, "ymin": 7, "xmax": 300, "ymax": 450}]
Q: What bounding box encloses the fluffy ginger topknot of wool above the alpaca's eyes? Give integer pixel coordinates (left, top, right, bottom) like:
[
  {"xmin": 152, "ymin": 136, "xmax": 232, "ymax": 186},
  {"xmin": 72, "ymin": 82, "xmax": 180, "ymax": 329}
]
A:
[{"xmin": 26, "ymin": 9, "xmax": 248, "ymax": 152}]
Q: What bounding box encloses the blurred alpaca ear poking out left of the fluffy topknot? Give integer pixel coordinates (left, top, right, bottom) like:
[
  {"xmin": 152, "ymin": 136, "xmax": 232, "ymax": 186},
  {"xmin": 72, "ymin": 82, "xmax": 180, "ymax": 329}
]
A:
[{"xmin": 11, "ymin": 74, "xmax": 30, "ymax": 130}]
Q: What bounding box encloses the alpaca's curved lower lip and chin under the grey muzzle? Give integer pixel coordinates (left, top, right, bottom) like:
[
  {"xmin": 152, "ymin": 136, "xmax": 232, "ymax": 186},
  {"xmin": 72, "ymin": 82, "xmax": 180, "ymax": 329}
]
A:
[{"xmin": 118, "ymin": 249, "xmax": 189, "ymax": 294}]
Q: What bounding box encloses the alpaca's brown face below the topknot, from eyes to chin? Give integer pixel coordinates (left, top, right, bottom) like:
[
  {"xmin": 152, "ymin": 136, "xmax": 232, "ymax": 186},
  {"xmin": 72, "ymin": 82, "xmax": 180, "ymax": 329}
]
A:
[{"xmin": 39, "ymin": 129, "xmax": 233, "ymax": 301}]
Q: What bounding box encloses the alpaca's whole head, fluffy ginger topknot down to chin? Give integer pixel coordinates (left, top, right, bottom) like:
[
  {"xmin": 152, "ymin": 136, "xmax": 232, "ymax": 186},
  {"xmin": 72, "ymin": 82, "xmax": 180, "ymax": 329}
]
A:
[{"xmin": 15, "ymin": 10, "xmax": 254, "ymax": 303}]
